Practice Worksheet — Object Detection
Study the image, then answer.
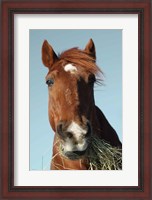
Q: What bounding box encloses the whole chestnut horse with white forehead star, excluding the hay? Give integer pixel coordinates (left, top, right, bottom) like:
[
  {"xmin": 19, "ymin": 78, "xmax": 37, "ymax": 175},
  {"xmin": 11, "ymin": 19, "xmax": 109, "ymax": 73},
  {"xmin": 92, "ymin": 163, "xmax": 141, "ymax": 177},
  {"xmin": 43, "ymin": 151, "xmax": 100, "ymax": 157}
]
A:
[{"xmin": 42, "ymin": 39, "xmax": 122, "ymax": 170}]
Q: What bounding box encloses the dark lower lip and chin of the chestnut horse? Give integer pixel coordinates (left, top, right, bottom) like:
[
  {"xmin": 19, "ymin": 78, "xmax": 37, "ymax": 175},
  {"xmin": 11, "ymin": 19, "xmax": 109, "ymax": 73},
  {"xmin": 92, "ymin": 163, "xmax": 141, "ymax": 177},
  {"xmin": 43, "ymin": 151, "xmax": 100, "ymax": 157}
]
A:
[{"xmin": 63, "ymin": 149, "xmax": 87, "ymax": 160}]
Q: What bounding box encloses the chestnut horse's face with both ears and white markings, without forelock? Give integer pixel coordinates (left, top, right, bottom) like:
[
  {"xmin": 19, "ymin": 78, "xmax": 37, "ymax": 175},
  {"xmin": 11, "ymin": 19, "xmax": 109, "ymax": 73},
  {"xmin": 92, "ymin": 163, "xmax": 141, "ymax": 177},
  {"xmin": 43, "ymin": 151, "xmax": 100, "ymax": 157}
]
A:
[{"xmin": 42, "ymin": 40, "xmax": 99, "ymax": 159}]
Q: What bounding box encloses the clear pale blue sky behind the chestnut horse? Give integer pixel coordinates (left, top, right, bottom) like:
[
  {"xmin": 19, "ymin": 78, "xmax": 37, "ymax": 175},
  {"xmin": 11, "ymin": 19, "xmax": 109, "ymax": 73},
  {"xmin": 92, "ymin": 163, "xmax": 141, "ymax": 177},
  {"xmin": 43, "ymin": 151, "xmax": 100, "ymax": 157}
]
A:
[{"xmin": 29, "ymin": 29, "xmax": 122, "ymax": 170}]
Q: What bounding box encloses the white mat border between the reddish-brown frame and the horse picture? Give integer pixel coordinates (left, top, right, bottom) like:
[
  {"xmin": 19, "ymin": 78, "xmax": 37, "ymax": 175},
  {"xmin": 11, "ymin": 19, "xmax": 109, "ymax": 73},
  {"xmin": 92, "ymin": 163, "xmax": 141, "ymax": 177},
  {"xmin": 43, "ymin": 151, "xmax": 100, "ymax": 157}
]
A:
[{"xmin": 14, "ymin": 14, "xmax": 138, "ymax": 186}]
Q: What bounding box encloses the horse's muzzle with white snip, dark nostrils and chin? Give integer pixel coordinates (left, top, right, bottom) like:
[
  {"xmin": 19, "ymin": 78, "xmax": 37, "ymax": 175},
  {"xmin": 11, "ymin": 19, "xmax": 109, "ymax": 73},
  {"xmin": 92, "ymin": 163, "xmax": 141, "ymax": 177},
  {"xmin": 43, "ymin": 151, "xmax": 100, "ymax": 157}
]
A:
[{"xmin": 57, "ymin": 119, "xmax": 92, "ymax": 160}]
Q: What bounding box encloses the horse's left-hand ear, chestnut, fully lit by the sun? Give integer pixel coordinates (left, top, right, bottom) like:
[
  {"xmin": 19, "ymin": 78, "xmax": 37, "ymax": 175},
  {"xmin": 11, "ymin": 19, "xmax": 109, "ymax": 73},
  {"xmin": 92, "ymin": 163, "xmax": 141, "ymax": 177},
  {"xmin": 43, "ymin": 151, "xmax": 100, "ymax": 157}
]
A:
[{"xmin": 42, "ymin": 40, "xmax": 58, "ymax": 68}]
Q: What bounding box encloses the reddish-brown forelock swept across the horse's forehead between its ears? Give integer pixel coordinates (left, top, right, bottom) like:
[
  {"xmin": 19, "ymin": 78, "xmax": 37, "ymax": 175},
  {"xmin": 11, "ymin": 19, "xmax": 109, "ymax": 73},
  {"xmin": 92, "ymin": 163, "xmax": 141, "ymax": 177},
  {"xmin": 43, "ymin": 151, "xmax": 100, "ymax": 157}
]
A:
[{"xmin": 59, "ymin": 47, "xmax": 102, "ymax": 75}]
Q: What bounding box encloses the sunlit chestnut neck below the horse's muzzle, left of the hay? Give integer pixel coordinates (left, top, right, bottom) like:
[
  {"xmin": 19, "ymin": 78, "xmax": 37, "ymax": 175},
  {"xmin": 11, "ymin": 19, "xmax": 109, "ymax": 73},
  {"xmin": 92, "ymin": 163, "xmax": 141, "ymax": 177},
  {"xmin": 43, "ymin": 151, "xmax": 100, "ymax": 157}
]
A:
[{"xmin": 51, "ymin": 134, "xmax": 88, "ymax": 170}]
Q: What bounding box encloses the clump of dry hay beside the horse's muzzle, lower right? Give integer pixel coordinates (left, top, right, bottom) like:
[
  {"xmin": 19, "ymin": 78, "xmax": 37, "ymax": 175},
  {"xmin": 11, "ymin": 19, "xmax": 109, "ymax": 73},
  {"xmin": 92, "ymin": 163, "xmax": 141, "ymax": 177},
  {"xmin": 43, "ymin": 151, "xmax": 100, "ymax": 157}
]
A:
[{"xmin": 87, "ymin": 137, "xmax": 122, "ymax": 170}]
